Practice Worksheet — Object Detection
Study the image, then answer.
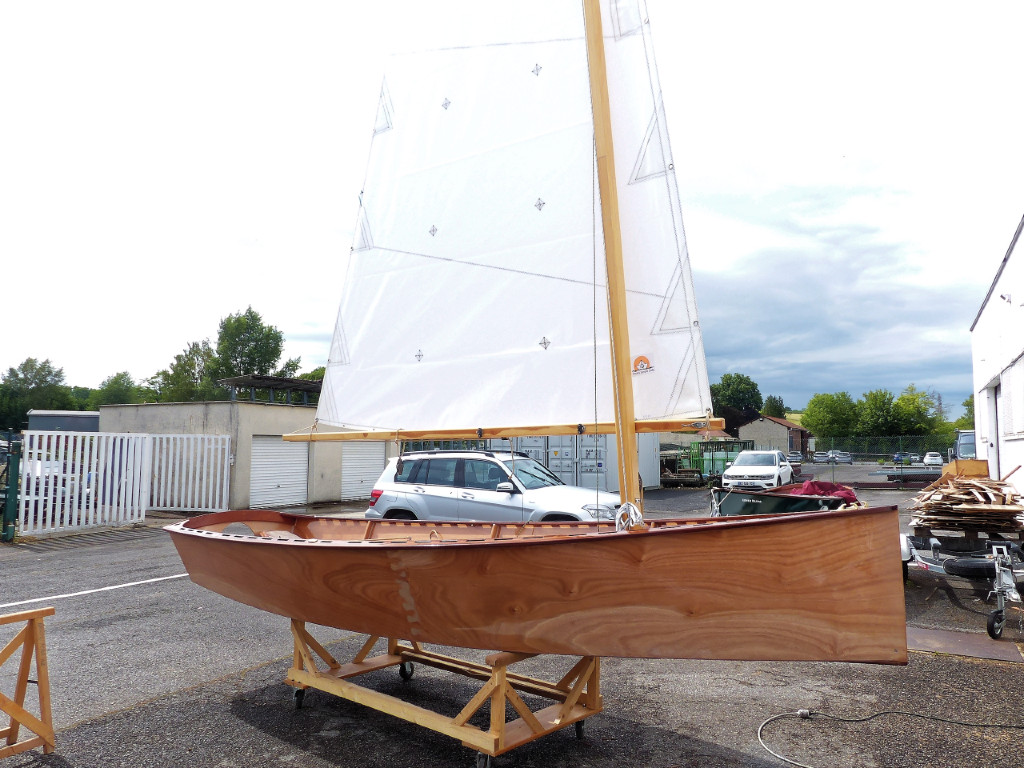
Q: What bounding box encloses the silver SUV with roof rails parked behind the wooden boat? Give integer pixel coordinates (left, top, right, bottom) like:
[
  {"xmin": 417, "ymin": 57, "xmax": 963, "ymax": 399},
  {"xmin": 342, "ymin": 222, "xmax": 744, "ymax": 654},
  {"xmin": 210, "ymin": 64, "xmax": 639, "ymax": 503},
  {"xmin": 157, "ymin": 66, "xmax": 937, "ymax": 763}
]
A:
[{"xmin": 366, "ymin": 451, "xmax": 618, "ymax": 522}]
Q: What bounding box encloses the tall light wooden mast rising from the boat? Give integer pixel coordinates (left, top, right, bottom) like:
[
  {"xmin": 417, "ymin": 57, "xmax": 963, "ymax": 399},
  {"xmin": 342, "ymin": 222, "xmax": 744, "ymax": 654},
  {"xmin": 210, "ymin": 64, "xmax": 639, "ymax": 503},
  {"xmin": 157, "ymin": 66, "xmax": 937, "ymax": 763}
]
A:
[{"xmin": 583, "ymin": 0, "xmax": 640, "ymax": 506}]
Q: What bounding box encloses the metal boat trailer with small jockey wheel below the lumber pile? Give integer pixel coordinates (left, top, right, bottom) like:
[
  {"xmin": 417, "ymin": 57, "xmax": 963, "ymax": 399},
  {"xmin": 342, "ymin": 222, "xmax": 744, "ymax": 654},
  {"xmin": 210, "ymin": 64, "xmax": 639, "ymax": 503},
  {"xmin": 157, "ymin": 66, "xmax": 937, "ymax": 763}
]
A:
[{"xmin": 900, "ymin": 527, "xmax": 1024, "ymax": 640}]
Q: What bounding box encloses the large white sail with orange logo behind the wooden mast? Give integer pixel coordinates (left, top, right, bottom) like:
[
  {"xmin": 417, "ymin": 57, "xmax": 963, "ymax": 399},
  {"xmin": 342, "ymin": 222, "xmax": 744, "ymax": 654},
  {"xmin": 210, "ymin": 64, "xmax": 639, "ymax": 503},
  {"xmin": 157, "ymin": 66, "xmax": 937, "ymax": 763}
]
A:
[{"xmin": 317, "ymin": 0, "xmax": 711, "ymax": 431}]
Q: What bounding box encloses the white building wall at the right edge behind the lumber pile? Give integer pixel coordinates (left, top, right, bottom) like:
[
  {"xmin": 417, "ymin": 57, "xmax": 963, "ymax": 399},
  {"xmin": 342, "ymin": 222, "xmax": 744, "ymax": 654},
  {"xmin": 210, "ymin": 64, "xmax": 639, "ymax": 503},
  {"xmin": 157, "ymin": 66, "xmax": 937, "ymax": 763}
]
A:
[{"xmin": 971, "ymin": 214, "xmax": 1024, "ymax": 487}]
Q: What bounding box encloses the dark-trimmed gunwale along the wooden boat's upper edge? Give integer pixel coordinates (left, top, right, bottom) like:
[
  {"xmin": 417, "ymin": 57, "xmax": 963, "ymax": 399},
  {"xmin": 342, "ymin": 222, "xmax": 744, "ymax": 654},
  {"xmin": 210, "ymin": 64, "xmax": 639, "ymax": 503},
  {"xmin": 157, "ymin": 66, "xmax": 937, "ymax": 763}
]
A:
[{"xmin": 164, "ymin": 505, "xmax": 897, "ymax": 549}]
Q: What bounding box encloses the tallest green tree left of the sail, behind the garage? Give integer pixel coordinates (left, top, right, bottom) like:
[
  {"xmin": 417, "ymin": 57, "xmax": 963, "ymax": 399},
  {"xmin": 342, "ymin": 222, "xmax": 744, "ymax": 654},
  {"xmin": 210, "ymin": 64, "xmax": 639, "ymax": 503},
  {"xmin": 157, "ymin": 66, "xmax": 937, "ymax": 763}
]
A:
[{"xmin": 212, "ymin": 306, "xmax": 299, "ymax": 381}]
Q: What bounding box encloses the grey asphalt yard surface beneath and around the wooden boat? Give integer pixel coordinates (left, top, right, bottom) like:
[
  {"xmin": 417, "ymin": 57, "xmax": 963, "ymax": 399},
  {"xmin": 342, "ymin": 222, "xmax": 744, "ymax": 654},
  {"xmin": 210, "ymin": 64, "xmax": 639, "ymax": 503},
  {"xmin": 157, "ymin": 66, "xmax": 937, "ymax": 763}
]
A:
[{"xmin": 0, "ymin": 479, "xmax": 1024, "ymax": 768}]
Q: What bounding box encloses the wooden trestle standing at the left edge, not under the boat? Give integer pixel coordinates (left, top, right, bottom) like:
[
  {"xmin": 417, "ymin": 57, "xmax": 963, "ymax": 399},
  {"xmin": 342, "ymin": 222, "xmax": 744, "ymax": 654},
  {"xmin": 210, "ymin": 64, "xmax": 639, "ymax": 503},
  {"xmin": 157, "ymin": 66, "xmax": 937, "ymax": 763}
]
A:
[{"xmin": 0, "ymin": 608, "xmax": 55, "ymax": 759}]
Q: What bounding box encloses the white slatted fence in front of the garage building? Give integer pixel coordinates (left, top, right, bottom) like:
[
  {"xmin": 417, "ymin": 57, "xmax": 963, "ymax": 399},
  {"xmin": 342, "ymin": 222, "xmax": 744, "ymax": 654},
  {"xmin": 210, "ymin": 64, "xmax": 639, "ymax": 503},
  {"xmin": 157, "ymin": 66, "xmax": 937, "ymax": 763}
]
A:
[{"xmin": 18, "ymin": 432, "xmax": 230, "ymax": 536}]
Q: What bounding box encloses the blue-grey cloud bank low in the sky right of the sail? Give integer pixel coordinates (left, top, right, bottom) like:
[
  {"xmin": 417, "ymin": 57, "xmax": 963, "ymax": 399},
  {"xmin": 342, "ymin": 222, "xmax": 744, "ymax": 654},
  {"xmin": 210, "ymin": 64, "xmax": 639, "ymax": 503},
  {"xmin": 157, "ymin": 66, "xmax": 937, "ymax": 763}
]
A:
[{"xmin": 692, "ymin": 187, "xmax": 977, "ymax": 408}]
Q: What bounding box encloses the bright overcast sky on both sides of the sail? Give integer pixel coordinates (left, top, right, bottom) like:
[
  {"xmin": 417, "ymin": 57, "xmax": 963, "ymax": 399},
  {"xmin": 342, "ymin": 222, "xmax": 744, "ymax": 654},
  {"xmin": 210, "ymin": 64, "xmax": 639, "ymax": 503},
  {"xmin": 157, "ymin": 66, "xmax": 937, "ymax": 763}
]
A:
[{"xmin": 0, "ymin": 0, "xmax": 1024, "ymax": 416}]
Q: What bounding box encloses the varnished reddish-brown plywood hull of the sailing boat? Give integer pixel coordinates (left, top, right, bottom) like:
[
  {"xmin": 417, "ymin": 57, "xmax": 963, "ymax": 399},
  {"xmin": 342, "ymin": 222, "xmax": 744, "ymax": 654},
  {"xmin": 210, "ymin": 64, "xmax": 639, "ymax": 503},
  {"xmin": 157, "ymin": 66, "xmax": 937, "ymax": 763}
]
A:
[{"xmin": 167, "ymin": 507, "xmax": 906, "ymax": 664}]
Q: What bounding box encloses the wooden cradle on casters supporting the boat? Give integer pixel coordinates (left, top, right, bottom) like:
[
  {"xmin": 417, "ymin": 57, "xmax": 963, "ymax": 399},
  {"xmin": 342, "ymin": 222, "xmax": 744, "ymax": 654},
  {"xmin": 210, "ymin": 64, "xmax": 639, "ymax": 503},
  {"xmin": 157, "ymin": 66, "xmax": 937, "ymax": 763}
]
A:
[{"xmin": 285, "ymin": 620, "xmax": 602, "ymax": 756}]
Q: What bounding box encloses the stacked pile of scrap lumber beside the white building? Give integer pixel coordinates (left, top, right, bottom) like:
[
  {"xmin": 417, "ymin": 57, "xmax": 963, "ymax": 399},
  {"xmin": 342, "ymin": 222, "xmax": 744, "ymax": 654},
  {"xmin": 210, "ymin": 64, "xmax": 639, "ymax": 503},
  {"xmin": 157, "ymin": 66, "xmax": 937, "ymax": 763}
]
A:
[{"xmin": 910, "ymin": 474, "xmax": 1024, "ymax": 531}]
